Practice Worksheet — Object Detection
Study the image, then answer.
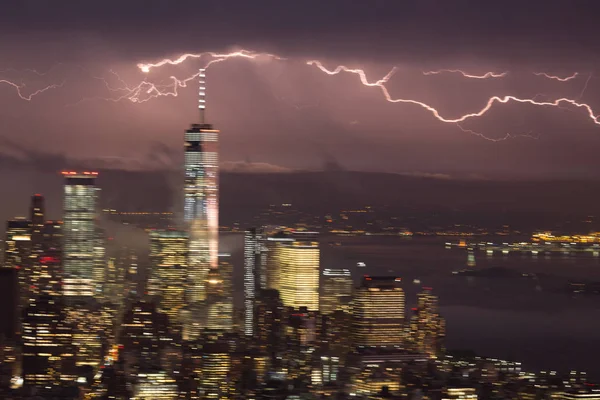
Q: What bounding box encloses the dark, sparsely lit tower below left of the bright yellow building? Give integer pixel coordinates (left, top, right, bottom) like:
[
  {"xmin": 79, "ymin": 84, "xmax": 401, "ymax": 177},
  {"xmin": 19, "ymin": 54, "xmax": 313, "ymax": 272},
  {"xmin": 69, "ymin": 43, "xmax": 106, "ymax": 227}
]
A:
[{"xmin": 253, "ymin": 289, "xmax": 285, "ymax": 357}]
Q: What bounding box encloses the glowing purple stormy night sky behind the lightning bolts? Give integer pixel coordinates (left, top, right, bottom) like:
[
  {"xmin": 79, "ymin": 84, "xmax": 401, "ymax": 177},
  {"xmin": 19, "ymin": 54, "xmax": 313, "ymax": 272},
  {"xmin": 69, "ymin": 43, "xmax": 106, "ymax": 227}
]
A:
[{"xmin": 0, "ymin": 0, "xmax": 600, "ymax": 179}]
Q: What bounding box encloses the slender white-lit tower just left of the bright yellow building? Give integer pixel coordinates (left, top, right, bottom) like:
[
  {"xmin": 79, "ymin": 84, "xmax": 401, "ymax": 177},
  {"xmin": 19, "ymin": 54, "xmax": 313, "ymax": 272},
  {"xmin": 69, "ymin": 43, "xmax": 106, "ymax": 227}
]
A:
[{"xmin": 244, "ymin": 228, "xmax": 266, "ymax": 336}]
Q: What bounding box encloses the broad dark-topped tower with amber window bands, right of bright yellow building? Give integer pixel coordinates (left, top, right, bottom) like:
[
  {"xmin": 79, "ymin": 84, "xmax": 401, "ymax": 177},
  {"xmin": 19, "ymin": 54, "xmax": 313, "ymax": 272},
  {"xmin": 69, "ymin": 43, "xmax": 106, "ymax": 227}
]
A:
[{"xmin": 352, "ymin": 276, "xmax": 404, "ymax": 347}]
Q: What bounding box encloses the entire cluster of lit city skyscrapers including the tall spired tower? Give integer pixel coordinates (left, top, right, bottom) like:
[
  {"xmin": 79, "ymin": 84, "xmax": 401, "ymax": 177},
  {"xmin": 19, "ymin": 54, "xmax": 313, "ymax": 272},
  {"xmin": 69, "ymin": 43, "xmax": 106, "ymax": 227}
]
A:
[{"xmin": 0, "ymin": 71, "xmax": 600, "ymax": 400}]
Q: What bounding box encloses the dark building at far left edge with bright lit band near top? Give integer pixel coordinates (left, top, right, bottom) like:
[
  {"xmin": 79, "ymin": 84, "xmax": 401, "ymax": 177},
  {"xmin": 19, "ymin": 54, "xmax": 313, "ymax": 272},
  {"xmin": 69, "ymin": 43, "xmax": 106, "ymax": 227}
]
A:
[{"xmin": 4, "ymin": 218, "xmax": 33, "ymax": 307}]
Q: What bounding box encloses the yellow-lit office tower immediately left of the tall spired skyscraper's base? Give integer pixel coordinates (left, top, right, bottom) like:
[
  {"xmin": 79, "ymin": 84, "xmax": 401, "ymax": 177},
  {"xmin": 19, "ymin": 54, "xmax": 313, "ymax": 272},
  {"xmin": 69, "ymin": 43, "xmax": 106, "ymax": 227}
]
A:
[{"xmin": 148, "ymin": 230, "xmax": 188, "ymax": 323}]
